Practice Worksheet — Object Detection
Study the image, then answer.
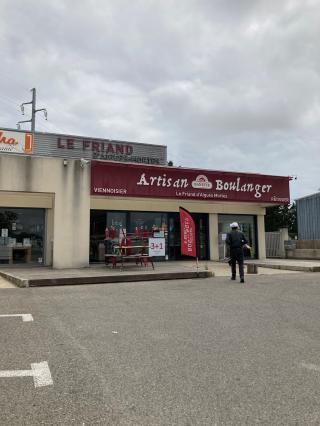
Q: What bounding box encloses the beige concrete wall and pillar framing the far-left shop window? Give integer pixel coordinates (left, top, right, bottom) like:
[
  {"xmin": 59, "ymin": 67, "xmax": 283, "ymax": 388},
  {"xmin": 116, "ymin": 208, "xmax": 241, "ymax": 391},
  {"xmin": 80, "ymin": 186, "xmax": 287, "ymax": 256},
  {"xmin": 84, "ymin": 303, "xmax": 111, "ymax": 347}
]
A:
[{"xmin": 0, "ymin": 154, "xmax": 90, "ymax": 268}]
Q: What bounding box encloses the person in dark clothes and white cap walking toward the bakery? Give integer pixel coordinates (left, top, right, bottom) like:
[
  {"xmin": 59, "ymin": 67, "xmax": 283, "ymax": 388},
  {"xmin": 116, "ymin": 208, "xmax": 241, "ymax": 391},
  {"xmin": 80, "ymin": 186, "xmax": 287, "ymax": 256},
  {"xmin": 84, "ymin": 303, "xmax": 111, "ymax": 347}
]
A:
[{"xmin": 226, "ymin": 222, "xmax": 250, "ymax": 283}]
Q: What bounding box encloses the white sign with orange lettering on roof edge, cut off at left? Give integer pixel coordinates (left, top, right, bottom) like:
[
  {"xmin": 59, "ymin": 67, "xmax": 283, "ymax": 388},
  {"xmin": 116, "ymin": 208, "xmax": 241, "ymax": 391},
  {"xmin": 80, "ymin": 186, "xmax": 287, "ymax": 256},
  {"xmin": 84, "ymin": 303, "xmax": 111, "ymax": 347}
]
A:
[{"xmin": 0, "ymin": 129, "xmax": 33, "ymax": 154}]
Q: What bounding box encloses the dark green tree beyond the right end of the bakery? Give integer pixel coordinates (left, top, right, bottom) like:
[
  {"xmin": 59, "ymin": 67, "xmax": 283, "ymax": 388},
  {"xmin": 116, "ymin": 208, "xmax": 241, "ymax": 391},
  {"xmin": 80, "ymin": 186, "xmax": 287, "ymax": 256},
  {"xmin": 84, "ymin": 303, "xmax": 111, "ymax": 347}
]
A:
[{"xmin": 265, "ymin": 203, "xmax": 297, "ymax": 238}]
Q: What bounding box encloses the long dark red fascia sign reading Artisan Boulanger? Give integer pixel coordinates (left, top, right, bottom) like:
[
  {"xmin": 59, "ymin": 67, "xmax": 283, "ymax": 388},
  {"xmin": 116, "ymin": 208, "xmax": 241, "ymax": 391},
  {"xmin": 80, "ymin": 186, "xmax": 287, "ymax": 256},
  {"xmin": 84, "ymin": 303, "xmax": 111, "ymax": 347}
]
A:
[{"xmin": 91, "ymin": 161, "xmax": 290, "ymax": 204}]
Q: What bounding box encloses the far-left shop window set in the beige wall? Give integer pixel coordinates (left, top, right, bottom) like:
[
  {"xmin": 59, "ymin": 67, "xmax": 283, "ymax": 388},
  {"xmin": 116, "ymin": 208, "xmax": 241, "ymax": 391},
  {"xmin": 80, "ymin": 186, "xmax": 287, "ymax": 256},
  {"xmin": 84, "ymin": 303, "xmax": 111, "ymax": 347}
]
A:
[{"xmin": 0, "ymin": 208, "xmax": 45, "ymax": 265}]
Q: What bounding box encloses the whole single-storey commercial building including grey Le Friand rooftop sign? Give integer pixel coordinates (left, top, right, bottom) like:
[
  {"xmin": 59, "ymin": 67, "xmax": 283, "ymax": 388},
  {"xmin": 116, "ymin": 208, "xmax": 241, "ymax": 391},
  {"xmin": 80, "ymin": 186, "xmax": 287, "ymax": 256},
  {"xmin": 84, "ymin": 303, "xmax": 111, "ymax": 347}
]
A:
[{"xmin": 0, "ymin": 125, "xmax": 289, "ymax": 269}]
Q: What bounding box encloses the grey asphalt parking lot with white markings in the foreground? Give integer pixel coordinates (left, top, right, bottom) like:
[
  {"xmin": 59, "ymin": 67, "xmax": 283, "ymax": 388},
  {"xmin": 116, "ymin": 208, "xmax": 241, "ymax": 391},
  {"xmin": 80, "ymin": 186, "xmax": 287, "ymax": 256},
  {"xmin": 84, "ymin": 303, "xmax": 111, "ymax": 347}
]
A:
[{"xmin": 0, "ymin": 273, "xmax": 320, "ymax": 426}]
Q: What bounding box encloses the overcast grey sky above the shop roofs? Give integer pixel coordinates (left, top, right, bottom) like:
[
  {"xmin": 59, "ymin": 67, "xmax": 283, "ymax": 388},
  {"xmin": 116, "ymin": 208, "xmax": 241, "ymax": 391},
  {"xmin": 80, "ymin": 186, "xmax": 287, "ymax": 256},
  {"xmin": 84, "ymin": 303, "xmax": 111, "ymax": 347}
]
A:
[{"xmin": 0, "ymin": 0, "xmax": 320, "ymax": 199}]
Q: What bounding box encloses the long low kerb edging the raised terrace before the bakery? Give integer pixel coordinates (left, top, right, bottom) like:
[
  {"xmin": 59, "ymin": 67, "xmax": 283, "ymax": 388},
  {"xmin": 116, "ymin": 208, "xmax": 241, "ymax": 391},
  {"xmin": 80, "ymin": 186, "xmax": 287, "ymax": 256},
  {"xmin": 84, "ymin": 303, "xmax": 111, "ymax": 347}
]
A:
[{"xmin": 0, "ymin": 271, "xmax": 214, "ymax": 287}]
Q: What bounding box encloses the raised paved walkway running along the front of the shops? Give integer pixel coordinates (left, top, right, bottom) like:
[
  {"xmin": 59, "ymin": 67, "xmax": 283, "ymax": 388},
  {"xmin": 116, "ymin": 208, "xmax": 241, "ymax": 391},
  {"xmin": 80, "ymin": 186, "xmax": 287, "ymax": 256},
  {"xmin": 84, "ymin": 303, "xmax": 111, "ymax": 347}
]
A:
[{"xmin": 0, "ymin": 259, "xmax": 310, "ymax": 288}]
